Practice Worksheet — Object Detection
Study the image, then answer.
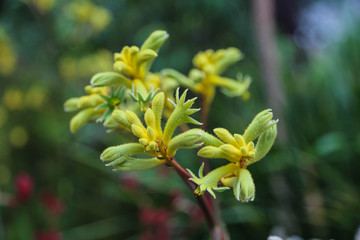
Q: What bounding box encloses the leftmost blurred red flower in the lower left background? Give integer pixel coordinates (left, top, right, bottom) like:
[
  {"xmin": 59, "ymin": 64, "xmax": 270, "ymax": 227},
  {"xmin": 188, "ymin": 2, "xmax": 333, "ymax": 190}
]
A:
[{"xmin": 15, "ymin": 173, "xmax": 34, "ymax": 202}]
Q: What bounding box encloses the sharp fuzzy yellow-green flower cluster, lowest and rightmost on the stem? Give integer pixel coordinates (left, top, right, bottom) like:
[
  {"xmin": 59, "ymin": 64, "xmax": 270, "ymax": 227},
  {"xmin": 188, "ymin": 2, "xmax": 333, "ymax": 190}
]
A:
[{"xmin": 188, "ymin": 109, "xmax": 277, "ymax": 202}]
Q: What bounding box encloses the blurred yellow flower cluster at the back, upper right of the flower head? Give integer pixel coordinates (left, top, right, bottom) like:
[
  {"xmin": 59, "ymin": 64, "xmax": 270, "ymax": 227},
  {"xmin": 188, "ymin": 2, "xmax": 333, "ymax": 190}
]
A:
[{"xmin": 162, "ymin": 47, "xmax": 251, "ymax": 105}]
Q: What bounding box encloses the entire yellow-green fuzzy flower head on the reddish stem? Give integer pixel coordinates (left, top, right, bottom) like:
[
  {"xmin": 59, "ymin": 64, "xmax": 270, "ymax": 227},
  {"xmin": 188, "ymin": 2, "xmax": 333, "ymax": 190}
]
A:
[{"xmin": 65, "ymin": 28, "xmax": 277, "ymax": 202}]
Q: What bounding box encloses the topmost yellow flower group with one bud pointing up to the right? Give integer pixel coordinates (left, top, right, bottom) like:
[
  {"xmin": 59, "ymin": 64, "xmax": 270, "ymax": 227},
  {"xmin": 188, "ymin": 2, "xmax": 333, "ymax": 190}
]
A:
[{"xmin": 90, "ymin": 30, "xmax": 178, "ymax": 111}]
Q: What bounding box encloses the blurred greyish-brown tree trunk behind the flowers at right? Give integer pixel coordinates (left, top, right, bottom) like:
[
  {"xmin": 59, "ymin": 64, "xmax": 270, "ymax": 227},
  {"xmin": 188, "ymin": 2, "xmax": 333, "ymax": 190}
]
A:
[{"xmin": 252, "ymin": 0, "xmax": 300, "ymax": 234}]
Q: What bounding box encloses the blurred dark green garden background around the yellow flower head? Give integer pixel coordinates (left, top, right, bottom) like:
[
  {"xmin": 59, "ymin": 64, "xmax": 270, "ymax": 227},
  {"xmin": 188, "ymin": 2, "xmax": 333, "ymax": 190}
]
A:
[{"xmin": 0, "ymin": 0, "xmax": 360, "ymax": 240}]
